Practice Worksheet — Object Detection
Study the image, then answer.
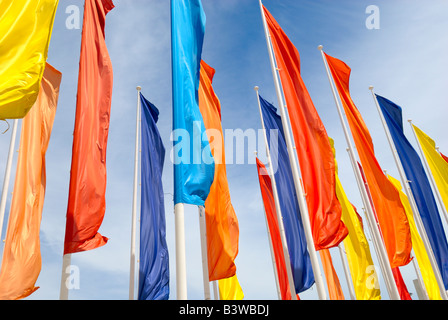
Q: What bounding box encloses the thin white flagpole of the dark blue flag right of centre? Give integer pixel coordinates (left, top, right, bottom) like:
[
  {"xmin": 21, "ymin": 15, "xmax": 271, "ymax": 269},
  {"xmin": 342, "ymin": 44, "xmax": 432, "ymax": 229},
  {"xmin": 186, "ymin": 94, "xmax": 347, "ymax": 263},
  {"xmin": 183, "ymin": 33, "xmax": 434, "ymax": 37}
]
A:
[{"xmin": 254, "ymin": 87, "xmax": 297, "ymax": 300}]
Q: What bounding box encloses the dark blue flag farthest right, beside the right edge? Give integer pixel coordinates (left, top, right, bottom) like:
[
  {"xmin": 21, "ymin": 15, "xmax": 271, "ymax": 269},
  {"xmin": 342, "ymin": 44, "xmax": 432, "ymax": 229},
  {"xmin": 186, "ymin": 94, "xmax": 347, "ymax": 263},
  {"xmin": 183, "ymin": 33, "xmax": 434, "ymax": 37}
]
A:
[{"xmin": 376, "ymin": 95, "xmax": 448, "ymax": 289}]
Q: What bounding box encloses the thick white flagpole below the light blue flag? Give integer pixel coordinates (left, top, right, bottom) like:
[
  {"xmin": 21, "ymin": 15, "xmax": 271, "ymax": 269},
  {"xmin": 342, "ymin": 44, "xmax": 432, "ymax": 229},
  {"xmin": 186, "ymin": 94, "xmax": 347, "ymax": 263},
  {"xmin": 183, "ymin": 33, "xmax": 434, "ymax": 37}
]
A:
[{"xmin": 174, "ymin": 203, "xmax": 187, "ymax": 300}]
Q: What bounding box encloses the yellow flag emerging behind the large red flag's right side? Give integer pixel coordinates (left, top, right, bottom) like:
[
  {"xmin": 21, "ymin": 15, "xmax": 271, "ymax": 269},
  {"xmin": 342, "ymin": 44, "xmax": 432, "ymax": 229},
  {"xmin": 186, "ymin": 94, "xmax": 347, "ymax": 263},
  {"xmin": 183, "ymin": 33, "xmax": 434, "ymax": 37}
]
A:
[{"xmin": 330, "ymin": 138, "xmax": 381, "ymax": 300}]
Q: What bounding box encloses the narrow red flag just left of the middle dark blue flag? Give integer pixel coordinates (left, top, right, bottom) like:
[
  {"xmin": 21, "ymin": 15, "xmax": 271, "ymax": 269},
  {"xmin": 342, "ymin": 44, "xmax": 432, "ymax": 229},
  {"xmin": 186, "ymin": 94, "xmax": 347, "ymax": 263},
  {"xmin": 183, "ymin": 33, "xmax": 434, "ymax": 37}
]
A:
[{"xmin": 256, "ymin": 158, "xmax": 291, "ymax": 300}]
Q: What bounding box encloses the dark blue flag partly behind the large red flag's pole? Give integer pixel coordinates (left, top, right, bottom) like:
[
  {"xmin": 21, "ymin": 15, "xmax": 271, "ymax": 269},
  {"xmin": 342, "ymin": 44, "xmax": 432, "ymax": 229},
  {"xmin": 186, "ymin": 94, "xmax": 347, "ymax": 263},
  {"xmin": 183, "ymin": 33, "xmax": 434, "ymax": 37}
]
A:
[{"xmin": 260, "ymin": 97, "xmax": 314, "ymax": 293}]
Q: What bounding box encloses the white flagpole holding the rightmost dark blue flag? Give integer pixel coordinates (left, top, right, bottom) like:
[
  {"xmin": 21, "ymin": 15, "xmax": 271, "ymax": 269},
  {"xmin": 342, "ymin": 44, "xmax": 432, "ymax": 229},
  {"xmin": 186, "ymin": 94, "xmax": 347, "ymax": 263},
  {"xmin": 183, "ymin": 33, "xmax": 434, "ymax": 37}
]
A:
[{"xmin": 369, "ymin": 86, "xmax": 448, "ymax": 300}]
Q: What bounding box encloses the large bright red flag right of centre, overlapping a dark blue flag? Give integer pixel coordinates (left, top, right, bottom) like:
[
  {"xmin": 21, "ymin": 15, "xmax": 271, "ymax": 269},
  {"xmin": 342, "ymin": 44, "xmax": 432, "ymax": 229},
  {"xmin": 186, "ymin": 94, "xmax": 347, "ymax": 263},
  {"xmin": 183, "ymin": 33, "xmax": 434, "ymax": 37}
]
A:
[{"xmin": 263, "ymin": 7, "xmax": 348, "ymax": 250}]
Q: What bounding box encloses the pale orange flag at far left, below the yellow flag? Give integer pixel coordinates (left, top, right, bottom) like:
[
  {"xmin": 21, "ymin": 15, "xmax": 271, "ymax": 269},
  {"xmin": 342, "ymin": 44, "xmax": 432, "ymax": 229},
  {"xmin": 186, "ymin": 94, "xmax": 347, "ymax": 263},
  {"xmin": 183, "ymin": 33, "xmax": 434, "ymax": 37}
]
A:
[{"xmin": 0, "ymin": 63, "xmax": 62, "ymax": 300}]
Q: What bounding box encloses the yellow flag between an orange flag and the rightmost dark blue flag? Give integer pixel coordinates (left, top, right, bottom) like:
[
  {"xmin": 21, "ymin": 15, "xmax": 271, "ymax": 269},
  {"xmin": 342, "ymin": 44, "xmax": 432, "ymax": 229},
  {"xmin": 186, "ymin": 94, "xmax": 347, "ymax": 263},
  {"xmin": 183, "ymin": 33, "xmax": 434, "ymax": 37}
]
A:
[{"xmin": 387, "ymin": 175, "xmax": 441, "ymax": 300}]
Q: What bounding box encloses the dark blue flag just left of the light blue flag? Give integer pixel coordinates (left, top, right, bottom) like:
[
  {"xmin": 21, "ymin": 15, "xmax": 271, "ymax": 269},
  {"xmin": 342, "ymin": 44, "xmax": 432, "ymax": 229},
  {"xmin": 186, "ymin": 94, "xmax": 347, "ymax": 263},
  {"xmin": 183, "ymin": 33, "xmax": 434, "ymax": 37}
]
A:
[{"xmin": 138, "ymin": 94, "xmax": 170, "ymax": 300}]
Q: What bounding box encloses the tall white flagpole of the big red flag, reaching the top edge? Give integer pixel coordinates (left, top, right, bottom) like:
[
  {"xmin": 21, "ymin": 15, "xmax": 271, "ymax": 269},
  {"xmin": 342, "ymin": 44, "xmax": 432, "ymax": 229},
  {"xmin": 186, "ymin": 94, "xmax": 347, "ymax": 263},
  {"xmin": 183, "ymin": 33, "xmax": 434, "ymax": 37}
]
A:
[{"xmin": 259, "ymin": 0, "xmax": 327, "ymax": 300}]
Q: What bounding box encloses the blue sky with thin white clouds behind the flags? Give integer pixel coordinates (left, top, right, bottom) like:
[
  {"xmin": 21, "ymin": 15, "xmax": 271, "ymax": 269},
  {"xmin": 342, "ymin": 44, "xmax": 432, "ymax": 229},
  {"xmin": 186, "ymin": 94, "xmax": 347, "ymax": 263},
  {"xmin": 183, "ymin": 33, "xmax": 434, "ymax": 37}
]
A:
[{"xmin": 0, "ymin": 0, "xmax": 448, "ymax": 300}]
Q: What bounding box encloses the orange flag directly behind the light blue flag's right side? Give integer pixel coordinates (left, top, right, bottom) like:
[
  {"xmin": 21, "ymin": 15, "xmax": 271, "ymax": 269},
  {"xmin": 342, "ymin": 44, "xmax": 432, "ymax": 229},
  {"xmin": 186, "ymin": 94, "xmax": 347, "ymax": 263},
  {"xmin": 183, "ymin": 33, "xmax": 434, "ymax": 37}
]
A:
[{"xmin": 199, "ymin": 61, "xmax": 239, "ymax": 281}]
